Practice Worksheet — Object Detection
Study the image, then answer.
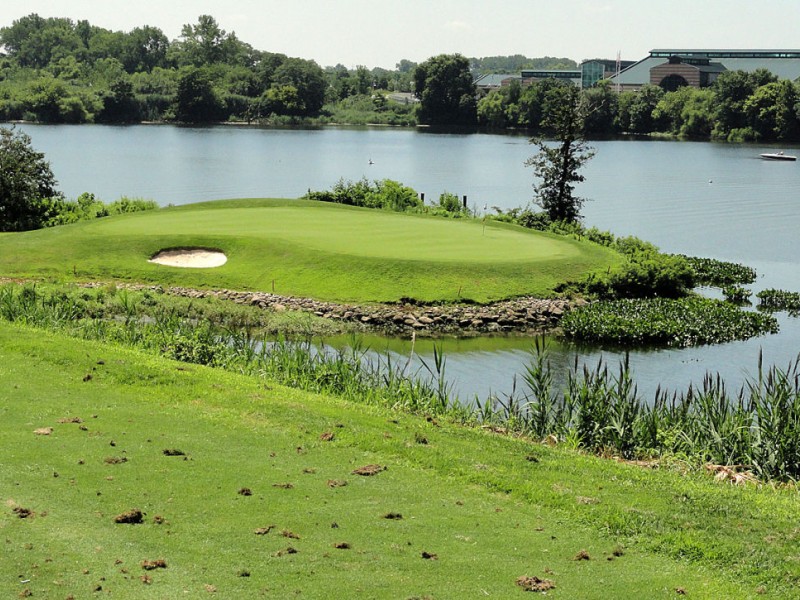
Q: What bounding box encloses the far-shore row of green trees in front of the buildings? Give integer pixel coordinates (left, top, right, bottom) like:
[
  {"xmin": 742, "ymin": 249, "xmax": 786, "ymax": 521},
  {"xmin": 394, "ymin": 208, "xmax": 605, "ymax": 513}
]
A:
[{"xmin": 476, "ymin": 69, "xmax": 800, "ymax": 141}]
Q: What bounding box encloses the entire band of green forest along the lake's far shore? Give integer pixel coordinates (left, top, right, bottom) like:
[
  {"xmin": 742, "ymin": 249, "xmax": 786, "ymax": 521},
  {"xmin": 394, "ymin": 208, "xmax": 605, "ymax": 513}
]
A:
[{"xmin": 0, "ymin": 14, "xmax": 800, "ymax": 141}]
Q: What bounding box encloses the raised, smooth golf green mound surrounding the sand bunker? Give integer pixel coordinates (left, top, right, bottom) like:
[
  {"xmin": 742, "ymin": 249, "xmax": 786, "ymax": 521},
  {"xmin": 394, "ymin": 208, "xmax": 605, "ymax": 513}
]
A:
[{"xmin": 0, "ymin": 200, "xmax": 620, "ymax": 302}]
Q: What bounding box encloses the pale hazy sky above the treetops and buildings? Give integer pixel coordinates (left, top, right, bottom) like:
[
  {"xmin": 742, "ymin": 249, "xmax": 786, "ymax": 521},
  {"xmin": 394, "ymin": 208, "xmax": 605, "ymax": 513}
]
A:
[{"xmin": 0, "ymin": 0, "xmax": 800, "ymax": 68}]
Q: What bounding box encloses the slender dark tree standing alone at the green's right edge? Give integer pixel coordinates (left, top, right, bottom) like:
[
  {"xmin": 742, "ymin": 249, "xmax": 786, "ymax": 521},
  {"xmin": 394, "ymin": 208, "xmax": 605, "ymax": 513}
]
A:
[{"xmin": 525, "ymin": 86, "xmax": 594, "ymax": 223}]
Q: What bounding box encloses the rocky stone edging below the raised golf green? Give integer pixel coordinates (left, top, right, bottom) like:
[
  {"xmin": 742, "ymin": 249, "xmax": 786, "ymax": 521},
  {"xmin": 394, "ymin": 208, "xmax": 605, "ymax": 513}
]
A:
[{"xmin": 126, "ymin": 286, "xmax": 586, "ymax": 335}]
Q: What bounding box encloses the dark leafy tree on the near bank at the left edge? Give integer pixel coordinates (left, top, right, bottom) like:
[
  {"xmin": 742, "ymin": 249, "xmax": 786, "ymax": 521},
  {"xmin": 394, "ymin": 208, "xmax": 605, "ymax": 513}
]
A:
[{"xmin": 0, "ymin": 127, "xmax": 62, "ymax": 231}]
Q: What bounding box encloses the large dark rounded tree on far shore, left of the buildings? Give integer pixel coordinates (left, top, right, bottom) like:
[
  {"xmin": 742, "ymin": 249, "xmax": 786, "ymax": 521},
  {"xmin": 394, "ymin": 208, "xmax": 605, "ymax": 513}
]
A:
[{"xmin": 414, "ymin": 54, "xmax": 477, "ymax": 125}]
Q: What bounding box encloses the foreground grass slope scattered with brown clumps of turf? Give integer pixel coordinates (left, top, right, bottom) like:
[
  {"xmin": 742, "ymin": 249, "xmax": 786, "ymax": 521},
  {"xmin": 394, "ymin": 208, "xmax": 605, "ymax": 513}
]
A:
[{"xmin": 0, "ymin": 325, "xmax": 800, "ymax": 599}]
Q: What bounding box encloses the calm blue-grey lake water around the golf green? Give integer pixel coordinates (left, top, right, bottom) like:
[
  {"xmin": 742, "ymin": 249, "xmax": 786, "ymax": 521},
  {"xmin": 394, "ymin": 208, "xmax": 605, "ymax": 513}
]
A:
[{"xmin": 21, "ymin": 125, "xmax": 800, "ymax": 397}]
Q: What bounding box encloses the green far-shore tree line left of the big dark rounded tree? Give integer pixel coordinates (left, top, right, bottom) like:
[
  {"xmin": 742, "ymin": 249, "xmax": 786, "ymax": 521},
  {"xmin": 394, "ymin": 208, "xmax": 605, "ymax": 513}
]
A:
[{"xmin": 0, "ymin": 14, "xmax": 416, "ymax": 123}]
